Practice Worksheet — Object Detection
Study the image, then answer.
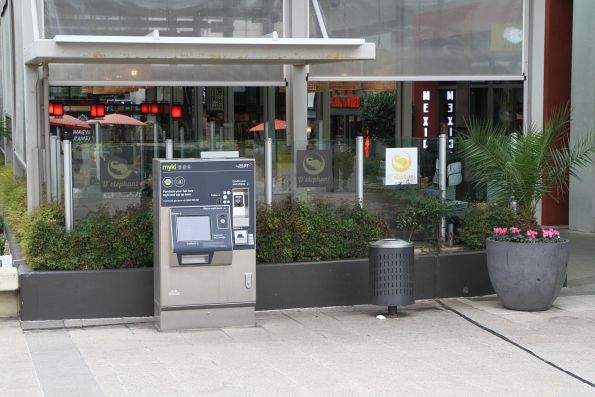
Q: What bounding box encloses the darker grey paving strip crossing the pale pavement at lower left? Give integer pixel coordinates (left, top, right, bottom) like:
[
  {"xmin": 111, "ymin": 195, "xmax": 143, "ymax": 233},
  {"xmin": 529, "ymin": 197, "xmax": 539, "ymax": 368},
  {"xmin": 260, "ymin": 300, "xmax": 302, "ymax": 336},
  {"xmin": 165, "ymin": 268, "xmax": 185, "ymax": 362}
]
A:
[{"xmin": 25, "ymin": 330, "xmax": 104, "ymax": 397}]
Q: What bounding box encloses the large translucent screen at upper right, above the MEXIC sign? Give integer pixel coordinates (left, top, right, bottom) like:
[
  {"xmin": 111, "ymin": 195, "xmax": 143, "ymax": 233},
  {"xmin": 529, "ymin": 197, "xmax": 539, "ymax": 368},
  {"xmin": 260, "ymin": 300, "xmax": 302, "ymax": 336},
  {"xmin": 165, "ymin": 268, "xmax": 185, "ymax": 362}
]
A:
[{"xmin": 310, "ymin": 0, "xmax": 523, "ymax": 76}]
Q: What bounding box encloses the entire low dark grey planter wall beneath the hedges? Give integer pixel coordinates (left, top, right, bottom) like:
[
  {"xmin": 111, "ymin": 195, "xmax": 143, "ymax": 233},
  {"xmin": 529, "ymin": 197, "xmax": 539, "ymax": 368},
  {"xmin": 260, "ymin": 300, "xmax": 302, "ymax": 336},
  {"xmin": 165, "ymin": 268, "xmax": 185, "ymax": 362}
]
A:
[{"xmin": 19, "ymin": 251, "xmax": 494, "ymax": 321}]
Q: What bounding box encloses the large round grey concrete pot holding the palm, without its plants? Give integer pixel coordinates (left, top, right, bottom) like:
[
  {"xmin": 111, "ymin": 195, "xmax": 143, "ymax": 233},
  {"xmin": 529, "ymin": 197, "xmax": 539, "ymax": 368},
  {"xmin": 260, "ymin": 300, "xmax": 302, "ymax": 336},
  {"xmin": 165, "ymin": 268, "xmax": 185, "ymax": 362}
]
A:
[{"xmin": 486, "ymin": 239, "xmax": 570, "ymax": 312}]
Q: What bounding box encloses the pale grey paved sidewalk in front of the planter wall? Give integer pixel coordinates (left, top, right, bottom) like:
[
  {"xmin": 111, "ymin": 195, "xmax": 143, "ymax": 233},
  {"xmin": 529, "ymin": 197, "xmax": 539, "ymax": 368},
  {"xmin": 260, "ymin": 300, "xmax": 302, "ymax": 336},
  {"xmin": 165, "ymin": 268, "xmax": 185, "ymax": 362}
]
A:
[{"xmin": 0, "ymin": 229, "xmax": 595, "ymax": 397}]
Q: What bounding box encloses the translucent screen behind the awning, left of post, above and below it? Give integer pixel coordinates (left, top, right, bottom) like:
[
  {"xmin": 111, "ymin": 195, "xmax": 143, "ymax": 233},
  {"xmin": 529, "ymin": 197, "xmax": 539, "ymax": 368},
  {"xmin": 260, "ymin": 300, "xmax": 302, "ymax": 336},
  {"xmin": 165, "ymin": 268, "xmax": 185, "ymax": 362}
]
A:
[{"xmin": 45, "ymin": 0, "xmax": 283, "ymax": 84}]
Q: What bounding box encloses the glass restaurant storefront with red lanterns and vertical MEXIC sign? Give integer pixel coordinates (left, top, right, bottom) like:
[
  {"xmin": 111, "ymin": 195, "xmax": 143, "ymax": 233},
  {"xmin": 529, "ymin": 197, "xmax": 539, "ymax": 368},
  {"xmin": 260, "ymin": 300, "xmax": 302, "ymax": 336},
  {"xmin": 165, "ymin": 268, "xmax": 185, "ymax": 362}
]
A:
[{"xmin": 0, "ymin": 0, "xmax": 595, "ymax": 232}]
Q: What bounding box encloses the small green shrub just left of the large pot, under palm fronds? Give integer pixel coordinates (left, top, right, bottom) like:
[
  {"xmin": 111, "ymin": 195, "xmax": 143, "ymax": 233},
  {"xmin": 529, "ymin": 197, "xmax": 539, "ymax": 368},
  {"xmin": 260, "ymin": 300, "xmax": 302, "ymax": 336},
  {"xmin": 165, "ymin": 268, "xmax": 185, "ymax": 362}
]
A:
[{"xmin": 459, "ymin": 203, "xmax": 519, "ymax": 249}]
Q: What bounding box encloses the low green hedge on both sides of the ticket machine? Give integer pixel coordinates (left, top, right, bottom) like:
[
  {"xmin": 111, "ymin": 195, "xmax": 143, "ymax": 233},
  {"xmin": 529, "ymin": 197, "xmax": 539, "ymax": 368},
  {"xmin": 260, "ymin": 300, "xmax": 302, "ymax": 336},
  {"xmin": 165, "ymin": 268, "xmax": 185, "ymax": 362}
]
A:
[{"xmin": 0, "ymin": 162, "xmax": 387, "ymax": 270}]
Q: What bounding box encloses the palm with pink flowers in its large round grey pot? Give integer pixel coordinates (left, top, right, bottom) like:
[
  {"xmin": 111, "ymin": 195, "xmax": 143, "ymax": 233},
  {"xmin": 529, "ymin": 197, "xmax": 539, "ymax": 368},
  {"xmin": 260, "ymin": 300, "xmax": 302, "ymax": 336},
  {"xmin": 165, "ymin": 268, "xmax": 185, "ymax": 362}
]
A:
[{"xmin": 458, "ymin": 108, "xmax": 595, "ymax": 311}]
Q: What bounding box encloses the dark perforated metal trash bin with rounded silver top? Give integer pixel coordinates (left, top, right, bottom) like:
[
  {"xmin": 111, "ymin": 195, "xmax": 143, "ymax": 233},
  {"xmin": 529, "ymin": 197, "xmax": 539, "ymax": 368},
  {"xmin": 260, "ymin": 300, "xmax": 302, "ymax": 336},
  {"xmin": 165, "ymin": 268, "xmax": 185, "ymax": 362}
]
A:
[{"xmin": 368, "ymin": 239, "xmax": 415, "ymax": 314}]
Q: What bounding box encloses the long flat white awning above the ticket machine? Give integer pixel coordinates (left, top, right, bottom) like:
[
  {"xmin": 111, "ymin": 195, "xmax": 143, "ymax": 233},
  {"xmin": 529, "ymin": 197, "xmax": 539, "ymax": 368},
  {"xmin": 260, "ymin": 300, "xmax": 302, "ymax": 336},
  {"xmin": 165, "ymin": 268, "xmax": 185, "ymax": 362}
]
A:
[{"xmin": 24, "ymin": 35, "xmax": 376, "ymax": 65}]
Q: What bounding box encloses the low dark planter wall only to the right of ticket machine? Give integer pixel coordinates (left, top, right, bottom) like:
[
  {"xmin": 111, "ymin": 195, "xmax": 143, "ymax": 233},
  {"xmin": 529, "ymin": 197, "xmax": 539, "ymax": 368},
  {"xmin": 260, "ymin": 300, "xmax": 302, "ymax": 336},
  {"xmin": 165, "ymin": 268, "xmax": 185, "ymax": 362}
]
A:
[{"xmin": 256, "ymin": 251, "xmax": 494, "ymax": 310}]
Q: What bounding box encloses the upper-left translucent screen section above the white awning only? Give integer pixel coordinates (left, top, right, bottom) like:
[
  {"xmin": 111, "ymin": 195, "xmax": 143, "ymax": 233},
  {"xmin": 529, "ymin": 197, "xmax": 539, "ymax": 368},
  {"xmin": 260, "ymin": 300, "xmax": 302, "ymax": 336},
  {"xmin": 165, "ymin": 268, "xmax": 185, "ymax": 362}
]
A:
[{"xmin": 44, "ymin": 0, "xmax": 283, "ymax": 38}]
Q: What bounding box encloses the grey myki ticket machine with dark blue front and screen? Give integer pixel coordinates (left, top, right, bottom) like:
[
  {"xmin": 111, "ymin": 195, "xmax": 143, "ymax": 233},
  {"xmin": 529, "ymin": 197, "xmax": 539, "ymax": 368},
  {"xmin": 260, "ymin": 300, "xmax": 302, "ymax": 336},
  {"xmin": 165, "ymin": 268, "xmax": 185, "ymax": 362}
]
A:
[{"xmin": 153, "ymin": 158, "xmax": 256, "ymax": 331}]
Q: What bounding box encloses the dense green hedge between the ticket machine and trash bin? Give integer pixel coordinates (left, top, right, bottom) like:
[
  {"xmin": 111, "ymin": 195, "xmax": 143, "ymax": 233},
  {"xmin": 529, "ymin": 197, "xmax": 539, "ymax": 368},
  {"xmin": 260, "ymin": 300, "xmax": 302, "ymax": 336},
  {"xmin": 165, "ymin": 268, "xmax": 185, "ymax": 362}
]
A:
[{"xmin": 256, "ymin": 201, "xmax": 387, "ymax": 263}]
